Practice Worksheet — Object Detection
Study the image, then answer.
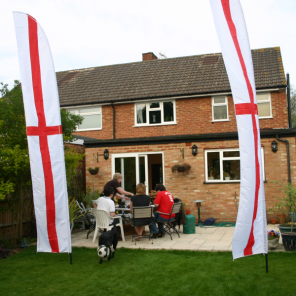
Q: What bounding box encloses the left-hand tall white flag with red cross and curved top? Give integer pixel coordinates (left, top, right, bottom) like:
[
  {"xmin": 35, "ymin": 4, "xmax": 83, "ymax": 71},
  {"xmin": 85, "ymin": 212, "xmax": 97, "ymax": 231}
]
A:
[{"xmin": 13, "ymin": 12, "xmax": 71, "ymax": 253}]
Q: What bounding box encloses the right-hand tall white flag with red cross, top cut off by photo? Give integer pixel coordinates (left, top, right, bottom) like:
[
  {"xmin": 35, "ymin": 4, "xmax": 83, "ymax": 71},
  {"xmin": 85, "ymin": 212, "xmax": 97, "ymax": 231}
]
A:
[{"xmin": 210, "ymin": 0, "xmax": 268, "ymax": 259}]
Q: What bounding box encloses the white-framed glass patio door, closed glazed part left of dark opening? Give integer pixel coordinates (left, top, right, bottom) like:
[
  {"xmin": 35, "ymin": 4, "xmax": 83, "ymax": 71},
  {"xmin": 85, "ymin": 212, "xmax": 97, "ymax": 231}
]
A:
[{"xmin": 111, "ymin": 153, "xmax": 149, "ymax": 194}]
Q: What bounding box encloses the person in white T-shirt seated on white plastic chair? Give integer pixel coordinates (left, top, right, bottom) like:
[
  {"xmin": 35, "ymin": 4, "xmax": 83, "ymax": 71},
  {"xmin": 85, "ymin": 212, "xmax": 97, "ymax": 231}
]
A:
[{"xmin": 94, "ymin": 187, "xmax": 125, "ymax": 237}]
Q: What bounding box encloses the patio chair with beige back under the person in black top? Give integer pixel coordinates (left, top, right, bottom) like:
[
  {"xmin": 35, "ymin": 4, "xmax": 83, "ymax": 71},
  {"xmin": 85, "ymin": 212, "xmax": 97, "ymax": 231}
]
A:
[{"xmin": 130, "ymin": 206, "xmax": 153, "ymax": 245}]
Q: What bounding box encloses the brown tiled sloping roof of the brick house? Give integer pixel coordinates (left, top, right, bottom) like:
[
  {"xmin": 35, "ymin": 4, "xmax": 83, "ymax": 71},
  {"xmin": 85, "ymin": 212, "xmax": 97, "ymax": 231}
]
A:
[{"xmin": 56, "ymin": 47, "xmax": 286, "ymax": 107}]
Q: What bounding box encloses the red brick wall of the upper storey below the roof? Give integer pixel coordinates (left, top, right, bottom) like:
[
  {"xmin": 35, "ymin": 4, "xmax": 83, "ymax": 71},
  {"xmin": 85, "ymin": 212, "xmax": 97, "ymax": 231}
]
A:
[{"xmin": 77, "ymin": 92, "xmax": 288, "ymax": 139}]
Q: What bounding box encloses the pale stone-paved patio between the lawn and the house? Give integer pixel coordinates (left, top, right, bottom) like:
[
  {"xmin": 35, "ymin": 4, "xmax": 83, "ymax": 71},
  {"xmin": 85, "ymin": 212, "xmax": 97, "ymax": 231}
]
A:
[{"xmin": 72, "ymin": 224, "xmax": 284, "ymax": 252}]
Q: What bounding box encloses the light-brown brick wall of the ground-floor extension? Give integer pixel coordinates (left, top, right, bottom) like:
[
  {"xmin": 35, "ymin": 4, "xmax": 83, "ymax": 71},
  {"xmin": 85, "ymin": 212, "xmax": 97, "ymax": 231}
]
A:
[{"xmin": 86, "ymin": 138, "xmax": 296, "ymax": 222}]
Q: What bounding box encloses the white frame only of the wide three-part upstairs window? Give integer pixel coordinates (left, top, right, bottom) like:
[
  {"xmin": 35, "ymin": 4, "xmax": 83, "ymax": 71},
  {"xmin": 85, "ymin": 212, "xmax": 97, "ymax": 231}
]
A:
[{"xmin": 134, "ymin": 100, "xmax": 177, "ymax": 127}]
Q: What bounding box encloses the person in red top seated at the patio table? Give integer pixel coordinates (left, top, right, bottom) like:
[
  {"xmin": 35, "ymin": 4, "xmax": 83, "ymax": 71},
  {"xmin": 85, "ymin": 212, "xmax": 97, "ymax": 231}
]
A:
[{"xmin": 150, "ymin": 184, "xmax": 175, "ymax": 238}]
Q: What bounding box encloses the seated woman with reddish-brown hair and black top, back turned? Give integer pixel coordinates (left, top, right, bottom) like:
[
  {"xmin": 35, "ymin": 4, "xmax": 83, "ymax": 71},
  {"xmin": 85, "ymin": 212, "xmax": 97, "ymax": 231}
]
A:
[{"xmin": 130, "ymin": 183, "xmax": 150, "ymax": 241}]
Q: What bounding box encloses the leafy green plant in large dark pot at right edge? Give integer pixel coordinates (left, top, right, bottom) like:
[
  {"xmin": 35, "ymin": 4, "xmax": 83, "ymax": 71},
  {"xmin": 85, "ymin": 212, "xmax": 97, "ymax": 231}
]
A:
[{"xmin": 278, "ymin": 183, "xmax": 296, "ymax": 251}]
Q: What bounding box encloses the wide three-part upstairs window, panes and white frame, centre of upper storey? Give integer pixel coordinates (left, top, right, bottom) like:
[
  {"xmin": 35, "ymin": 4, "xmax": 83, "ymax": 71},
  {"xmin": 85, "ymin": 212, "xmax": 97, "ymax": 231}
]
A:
[{"xmin": 135, "ymin": 101, "xmax": 176, "ymax": 126}]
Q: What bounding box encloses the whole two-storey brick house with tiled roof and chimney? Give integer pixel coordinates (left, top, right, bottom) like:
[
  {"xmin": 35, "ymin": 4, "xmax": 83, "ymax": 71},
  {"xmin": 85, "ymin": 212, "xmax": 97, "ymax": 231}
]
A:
[{"xmin": 57, "ymin": 47, "xmax": 296, "ymax": 221}]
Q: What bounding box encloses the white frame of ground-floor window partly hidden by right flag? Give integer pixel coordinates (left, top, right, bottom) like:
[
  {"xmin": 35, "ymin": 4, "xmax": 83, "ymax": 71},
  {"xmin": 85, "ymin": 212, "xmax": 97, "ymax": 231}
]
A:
[{"xmin": 205, "ymin": 147, "xmax": 266, "ymax": 183}]
